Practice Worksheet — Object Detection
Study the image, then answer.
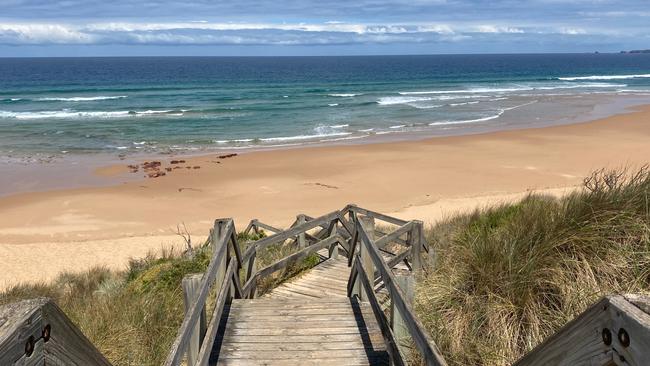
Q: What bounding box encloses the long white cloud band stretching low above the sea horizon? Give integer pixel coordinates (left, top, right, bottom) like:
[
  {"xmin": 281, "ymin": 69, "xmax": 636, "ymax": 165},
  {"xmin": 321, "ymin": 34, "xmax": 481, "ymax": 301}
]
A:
[{"xmin": 0, "ymin": 21, "xmax": 624, "ymax": 45}]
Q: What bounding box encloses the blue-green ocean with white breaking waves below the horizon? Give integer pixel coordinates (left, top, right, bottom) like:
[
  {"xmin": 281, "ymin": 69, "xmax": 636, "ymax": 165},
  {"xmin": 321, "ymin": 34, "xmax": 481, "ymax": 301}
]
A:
[{"xmin": 0, "ymin": 54, "xmax": 650, "ymax": 159}]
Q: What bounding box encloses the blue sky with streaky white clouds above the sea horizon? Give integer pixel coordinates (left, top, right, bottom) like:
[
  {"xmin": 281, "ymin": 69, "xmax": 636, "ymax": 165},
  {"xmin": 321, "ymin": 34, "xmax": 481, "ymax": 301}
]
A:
[{"xmin": 0, "ymin": 0, "xmax": 650, "ymax": 57}]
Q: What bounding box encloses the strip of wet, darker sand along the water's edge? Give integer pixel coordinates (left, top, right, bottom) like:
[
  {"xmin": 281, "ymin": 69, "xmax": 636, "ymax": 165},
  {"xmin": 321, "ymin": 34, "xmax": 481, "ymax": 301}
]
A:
[{"xmin": 0, "ymin": 96, "xmax": 650, "ymax": 198}]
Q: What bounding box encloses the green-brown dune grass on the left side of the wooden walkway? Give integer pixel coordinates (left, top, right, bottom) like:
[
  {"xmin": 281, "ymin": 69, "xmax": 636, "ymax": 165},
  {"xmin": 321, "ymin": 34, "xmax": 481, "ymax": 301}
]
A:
[{"xmin": 0, "ymin": 232, "xmax": 319, "ymax": 366}]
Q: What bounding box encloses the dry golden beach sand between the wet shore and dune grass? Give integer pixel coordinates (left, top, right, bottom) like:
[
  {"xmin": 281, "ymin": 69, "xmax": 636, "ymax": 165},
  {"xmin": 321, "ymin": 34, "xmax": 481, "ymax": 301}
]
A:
[{"xmin": 0, "ymin": 106, "xmax": 650, "ymax": 288}]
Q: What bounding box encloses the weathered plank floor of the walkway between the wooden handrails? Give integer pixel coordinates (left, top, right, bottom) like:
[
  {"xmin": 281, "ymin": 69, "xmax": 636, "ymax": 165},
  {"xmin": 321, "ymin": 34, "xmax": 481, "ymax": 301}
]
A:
[{"xmin": 211, "ymin": 258, "xmax": 388, "ymax": 365}]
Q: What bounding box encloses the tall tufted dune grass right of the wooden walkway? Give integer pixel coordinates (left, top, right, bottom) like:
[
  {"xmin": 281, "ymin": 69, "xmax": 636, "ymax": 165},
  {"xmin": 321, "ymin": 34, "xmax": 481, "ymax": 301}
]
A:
[{"xmin": 416, "ymin": 167, "xmax": 650, "ymax": 365}]
